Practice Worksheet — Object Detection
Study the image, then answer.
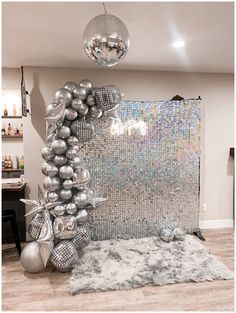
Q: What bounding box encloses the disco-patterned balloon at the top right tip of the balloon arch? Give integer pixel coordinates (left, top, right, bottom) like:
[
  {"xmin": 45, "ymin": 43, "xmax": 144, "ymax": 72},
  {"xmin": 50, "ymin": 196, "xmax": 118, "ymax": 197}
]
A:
[{"xmin": 95, "ymin": 85, "xmax": 121, "ymax": 111}]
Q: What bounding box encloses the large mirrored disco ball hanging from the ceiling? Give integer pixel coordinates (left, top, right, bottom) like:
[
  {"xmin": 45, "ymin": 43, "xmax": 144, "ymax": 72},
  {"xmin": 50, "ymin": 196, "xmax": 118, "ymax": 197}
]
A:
[{"xmin": 84, "ymin": 14, "xmax": 129, "ymax": 66}]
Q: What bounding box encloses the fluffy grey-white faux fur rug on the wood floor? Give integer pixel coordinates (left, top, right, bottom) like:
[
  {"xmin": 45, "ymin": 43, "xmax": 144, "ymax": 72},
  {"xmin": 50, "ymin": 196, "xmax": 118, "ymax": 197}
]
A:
[{"xmin": 70, "ymin": 235, "xmax": 233, "ymax": 294}]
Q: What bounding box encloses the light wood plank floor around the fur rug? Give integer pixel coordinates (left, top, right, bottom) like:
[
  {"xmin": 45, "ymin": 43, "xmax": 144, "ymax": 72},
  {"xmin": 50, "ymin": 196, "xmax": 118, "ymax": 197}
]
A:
[{"xmin": 2, "ymin": 229, "xmax": 234, "ymax": 311}]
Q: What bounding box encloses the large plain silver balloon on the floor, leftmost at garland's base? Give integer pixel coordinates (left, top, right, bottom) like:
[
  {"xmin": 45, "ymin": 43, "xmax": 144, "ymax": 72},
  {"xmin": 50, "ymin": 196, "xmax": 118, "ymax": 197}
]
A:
[{"xmin": 20, "ymin": 241, "xmax": 45, "ymax": 273}]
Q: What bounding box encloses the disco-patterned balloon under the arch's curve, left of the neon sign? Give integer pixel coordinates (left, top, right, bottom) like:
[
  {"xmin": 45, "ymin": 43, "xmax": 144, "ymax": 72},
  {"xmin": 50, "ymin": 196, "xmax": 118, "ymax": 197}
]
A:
[{"xmin": 71, "ymin": 119, "xmax": 94, "ymax": 142}]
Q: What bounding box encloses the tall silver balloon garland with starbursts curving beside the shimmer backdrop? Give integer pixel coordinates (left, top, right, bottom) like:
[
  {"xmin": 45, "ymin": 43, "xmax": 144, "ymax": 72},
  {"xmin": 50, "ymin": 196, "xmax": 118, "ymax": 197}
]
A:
[{"xmin": 21, "ymin": 79, "xmax": 121, "ymax": 272}]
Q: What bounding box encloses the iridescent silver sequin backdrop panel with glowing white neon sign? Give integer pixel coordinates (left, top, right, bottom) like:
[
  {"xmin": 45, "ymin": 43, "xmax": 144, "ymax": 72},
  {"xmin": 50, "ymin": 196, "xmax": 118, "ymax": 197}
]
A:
[{"xmin": 80, "ymin": 100, "xmax": 200, "ymax": 240}]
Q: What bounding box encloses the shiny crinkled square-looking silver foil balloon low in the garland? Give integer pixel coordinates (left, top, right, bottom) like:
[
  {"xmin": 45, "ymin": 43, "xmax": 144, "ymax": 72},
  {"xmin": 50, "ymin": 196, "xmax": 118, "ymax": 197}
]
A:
[{"xmin": 53, "ymin": 215, "xmax": 77, "ymax": 239}]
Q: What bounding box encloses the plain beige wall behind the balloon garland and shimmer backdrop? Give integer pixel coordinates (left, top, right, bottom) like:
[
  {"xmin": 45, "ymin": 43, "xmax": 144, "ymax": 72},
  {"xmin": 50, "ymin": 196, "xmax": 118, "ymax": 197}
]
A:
[{"xmin": 3, "ymin": 67, "xmax": 234, "ymax": 220}]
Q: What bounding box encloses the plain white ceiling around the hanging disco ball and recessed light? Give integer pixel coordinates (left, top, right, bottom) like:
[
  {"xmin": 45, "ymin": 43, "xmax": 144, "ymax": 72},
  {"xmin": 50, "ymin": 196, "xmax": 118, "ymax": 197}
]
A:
[{"xmin": 2, "ymin": 2, "xmax": 234, "ymax": 73}]
